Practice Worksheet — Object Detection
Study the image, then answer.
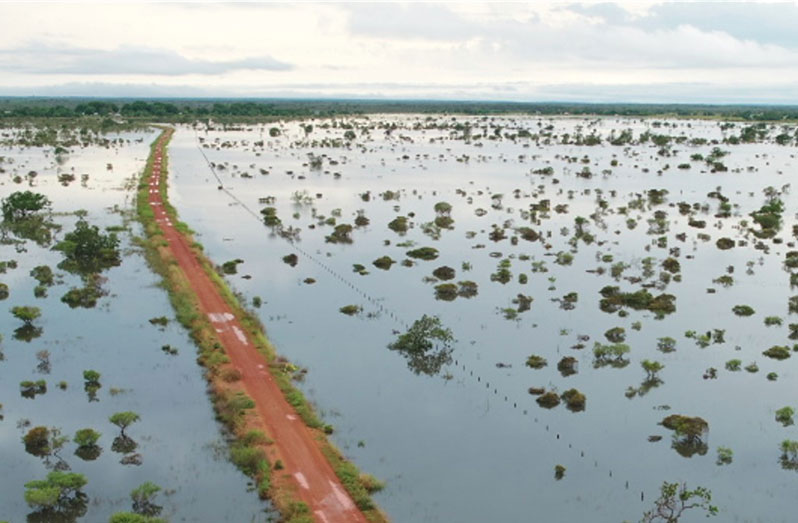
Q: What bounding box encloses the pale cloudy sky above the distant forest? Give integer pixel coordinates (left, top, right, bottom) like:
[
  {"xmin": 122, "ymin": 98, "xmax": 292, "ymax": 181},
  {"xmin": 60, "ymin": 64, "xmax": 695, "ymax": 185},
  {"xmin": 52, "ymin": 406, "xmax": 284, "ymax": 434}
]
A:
[{"xmin": 0, "ymin": 2, "xmax": 798, "ymax": 104}]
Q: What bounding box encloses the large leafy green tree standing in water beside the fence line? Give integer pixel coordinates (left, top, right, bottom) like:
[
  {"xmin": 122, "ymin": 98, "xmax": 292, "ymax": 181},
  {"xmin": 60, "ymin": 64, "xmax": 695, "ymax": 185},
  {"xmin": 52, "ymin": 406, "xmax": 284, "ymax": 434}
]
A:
[{"xmin": 388, "ymin": 314, "xmax": 453, "ymax": 376}]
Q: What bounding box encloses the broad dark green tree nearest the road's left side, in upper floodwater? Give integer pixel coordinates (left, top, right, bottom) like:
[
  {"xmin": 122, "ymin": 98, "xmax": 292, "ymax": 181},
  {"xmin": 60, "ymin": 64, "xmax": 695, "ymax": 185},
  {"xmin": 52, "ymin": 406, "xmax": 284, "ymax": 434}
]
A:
[{"xmin": 55, "ymin": 219, "xmax": 121, "ymax": 274}]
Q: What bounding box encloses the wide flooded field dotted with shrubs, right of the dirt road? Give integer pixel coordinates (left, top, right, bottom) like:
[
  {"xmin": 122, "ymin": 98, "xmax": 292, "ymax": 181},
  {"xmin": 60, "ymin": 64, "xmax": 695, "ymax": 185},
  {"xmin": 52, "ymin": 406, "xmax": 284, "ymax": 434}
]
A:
[{"xmin": 164, "ymin": 116, "xmax": 798, "ymax": 522}]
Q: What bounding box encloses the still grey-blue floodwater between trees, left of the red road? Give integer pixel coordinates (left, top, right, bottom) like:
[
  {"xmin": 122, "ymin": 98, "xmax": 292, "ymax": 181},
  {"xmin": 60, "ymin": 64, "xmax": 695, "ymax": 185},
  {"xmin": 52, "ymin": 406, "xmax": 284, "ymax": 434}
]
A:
[{"xmin": 0, "ymin": 131, "xmax": 276, "ymax": 523}]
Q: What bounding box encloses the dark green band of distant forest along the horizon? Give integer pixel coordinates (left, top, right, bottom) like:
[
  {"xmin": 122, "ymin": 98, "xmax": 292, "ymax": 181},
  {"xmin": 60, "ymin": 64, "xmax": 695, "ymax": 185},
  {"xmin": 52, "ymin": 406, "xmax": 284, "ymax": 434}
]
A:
[{"xmin": 0, "ymin": 97, "xmax": 798, "ymax": 122}]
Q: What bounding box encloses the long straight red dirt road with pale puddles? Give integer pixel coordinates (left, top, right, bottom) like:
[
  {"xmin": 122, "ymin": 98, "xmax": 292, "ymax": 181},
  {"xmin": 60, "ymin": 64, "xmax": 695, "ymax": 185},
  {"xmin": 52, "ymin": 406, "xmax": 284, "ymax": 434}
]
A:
[{"xmin": 149, "ymin": 133, "xmax": 367, "ymax": 523}]
